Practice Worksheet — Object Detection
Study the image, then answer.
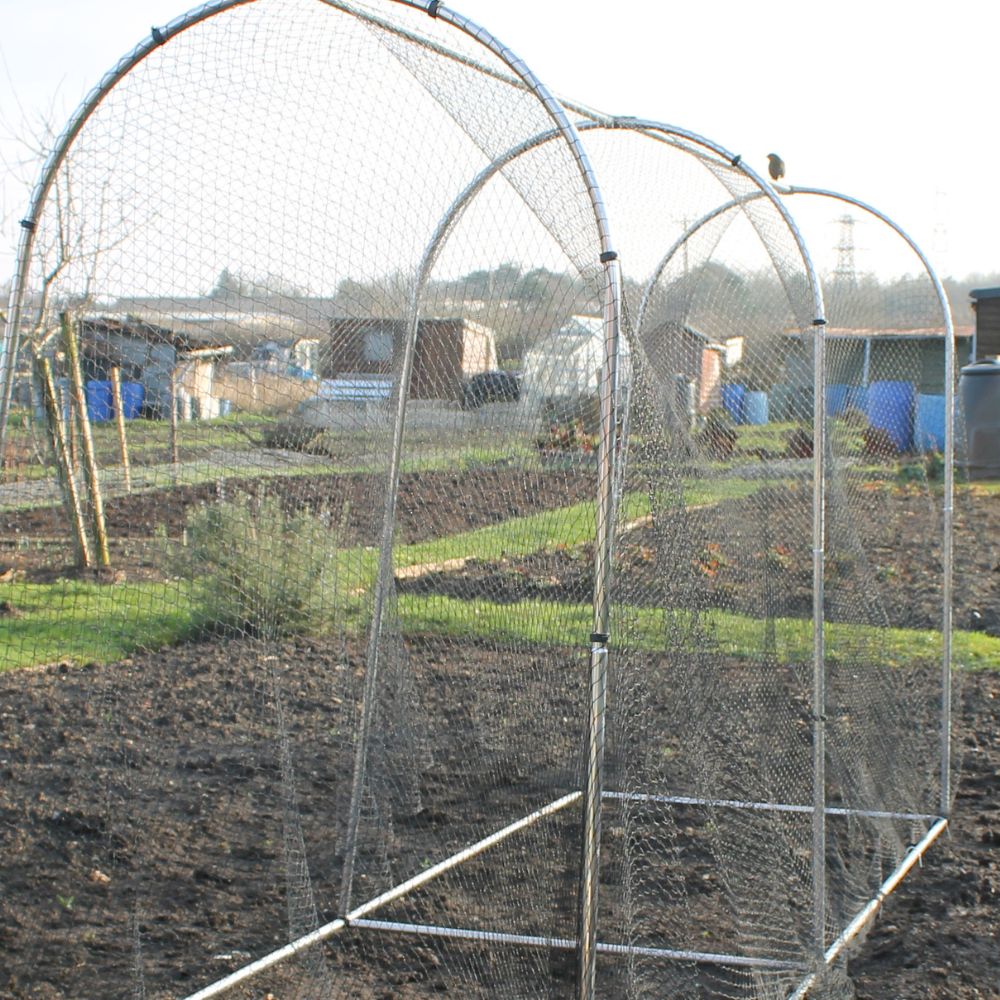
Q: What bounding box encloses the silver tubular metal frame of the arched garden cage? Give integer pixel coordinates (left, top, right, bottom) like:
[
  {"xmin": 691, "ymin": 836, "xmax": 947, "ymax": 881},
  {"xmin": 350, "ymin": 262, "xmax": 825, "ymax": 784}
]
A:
[{"xmin": 0, "ymin": 0, "xmax": 955, "ymax": 1000}]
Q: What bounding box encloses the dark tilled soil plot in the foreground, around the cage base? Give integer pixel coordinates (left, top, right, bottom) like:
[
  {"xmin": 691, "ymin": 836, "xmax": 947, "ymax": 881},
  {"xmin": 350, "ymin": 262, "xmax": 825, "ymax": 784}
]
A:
[{"xmin": 0, "ymin": 640, "xmax": 1000, "ymax": 1000}]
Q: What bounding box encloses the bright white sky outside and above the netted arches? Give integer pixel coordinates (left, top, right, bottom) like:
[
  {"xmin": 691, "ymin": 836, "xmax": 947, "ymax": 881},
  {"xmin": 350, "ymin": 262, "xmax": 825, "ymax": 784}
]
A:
[{"xmin": 0, "ymin": 0, "xmax": 1000, "ymax": 277}]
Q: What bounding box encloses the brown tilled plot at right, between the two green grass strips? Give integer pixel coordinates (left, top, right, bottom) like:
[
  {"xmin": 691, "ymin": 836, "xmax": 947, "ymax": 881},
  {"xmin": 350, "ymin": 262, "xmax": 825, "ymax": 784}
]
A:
[{"xmin": 400, "ymin": 489, "xmax": 1000, "ymax": 636}]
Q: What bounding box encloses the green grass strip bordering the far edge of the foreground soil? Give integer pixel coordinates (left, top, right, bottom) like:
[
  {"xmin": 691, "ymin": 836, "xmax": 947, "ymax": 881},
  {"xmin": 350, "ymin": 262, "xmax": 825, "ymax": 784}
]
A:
[{"xmin": 0, "ymin": 569, "xmax": 1000, "ymax": 670}]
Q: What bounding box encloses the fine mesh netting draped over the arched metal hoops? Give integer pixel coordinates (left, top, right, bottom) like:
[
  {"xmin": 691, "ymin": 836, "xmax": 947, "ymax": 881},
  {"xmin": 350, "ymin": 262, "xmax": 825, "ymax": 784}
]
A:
[{"xmin": 0, "ymin": 0, "xmax": 948, "ymax": 1000}]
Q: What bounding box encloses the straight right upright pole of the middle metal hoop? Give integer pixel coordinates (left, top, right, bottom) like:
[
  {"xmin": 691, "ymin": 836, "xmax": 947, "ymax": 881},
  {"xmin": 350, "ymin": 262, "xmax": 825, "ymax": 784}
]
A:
[{"xmin": 812, "ymin": 319, "xmax": 826, "ymax": 972}]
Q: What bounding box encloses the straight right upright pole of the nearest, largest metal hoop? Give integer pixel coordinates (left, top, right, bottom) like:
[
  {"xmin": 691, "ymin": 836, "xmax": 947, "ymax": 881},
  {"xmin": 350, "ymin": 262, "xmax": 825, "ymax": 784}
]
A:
[{"xmin": 577, "ymin": 251, "xmax": 621, "ymax": 1000}]
